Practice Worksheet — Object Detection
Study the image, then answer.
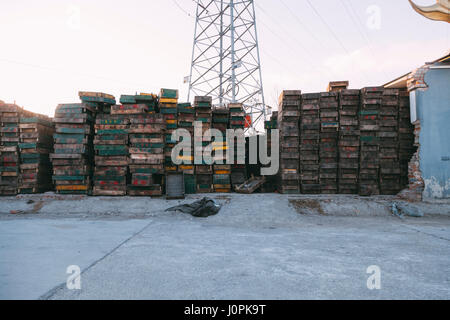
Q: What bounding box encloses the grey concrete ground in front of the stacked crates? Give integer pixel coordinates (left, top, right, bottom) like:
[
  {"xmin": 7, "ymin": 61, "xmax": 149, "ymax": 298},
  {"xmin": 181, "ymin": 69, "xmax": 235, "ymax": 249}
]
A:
[{"xmin": 0, "ymin": 193, "xmax": 450, "ymax": 299}]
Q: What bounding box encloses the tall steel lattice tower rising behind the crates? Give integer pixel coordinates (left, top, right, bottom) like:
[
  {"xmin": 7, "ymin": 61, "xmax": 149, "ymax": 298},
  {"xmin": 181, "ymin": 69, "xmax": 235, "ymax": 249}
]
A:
[{"xmin": 188, "ymin": 0, "xmax": 266, "ymax": 132}]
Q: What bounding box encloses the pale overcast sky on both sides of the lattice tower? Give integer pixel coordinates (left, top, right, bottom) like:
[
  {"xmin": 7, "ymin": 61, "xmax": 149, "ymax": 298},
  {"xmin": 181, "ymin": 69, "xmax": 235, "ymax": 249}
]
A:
[{"xmin": 0, "ymin": 0, "xmax": 450, "ymax": 115}]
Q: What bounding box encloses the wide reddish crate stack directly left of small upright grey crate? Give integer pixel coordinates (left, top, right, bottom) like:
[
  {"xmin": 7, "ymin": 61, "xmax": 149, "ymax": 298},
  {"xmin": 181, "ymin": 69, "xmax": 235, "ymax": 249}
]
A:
[{"xmin": 124, "ymin": 105, "xmax": 166, "ymax": 196}]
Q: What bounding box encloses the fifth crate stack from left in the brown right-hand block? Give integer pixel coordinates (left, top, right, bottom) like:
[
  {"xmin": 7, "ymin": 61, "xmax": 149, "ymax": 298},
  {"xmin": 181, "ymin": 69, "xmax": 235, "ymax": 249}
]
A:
[{"xmin": 359, "ymin": 87, "xmax": 384, "ymax": 196}]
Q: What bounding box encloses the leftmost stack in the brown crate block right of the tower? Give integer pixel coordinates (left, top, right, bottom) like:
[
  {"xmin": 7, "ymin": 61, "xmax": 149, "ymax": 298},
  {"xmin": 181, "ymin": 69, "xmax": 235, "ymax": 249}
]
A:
[{"xmin": 278, "ymin": 90, "xmax": 300, "ymax": 194}]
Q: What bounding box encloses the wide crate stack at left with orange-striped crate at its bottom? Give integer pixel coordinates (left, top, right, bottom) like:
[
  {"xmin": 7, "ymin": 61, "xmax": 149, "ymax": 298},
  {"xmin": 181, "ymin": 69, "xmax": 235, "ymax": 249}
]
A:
[{"xmin": 50, "ymin": 103, "xmax": 96, "ymax": 194}]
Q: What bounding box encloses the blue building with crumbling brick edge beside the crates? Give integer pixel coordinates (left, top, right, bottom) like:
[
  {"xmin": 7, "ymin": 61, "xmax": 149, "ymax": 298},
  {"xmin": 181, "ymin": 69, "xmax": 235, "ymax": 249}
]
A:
[{"xmin": 385, "ymin": 53, "xmax": 450, "ymax": 199}]
